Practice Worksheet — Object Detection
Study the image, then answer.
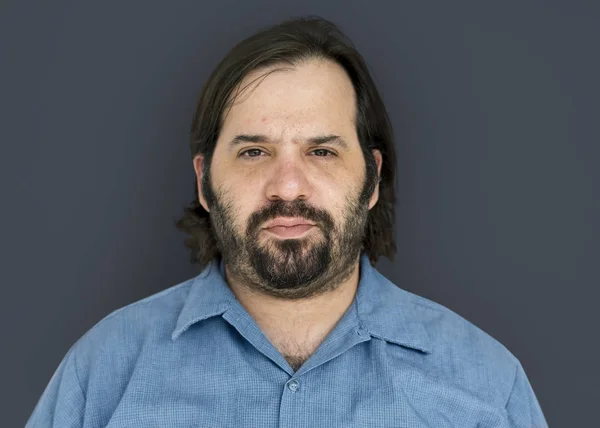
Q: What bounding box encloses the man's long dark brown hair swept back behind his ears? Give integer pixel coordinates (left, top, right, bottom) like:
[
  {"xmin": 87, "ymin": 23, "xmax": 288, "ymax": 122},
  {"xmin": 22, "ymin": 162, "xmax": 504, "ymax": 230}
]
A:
[{"xmin": 175, "ymin": 16, "xmax": 396, "ymax": 268}]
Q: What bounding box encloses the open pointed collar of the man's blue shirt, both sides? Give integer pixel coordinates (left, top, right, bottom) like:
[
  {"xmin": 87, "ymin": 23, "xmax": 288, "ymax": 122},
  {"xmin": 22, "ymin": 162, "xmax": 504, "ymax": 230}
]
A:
[{"xmin": 171, "ymin": 253, "xmax": 431, "ymax": 353}]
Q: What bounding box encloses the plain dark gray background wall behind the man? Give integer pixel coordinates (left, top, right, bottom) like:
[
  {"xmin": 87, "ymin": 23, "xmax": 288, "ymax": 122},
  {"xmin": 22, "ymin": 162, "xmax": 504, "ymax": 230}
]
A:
[{"xmin": 0, "ymin": 0, "xmax": 600, "ymax": 427}]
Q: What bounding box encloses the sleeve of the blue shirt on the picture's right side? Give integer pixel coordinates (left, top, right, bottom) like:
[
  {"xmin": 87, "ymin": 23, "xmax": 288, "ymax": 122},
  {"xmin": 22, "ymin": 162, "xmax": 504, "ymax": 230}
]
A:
[{"xmin": 506, "ymin": 363, "xmax": 548, "ymax": 428}]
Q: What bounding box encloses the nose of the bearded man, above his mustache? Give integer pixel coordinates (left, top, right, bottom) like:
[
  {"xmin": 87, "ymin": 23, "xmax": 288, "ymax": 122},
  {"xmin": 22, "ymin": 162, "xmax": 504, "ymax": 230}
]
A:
[{"xmin": 265, "ymin": 156, "xmax": 310, "ymax": 201}]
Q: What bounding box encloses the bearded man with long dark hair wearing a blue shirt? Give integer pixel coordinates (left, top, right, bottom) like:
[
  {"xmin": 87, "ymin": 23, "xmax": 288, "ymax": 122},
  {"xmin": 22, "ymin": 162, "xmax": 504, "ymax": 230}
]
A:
[{"xmin": 27, "ymin": 18, "xmax": 547, "ymax": 428}]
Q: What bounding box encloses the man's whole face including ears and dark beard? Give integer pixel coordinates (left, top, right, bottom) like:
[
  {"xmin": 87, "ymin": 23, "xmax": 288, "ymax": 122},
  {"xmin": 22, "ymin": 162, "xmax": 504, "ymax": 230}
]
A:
[{"xmin": 194, "ymin": 60, "xmax": 382, "ymax": 299}]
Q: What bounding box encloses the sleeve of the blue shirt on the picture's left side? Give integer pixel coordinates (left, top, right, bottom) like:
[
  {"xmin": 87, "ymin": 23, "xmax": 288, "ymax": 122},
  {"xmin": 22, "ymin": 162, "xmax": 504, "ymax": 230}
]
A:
[{"xmin": 25, "ymin": 345, "xmax": 85, "ymax": 428}]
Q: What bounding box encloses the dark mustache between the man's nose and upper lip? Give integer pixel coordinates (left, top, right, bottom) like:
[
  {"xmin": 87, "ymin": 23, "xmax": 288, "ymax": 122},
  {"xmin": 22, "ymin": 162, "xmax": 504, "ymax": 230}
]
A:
[{"xmin": 246, "ymin": 199, "xmax": 334, "ymax": 235}]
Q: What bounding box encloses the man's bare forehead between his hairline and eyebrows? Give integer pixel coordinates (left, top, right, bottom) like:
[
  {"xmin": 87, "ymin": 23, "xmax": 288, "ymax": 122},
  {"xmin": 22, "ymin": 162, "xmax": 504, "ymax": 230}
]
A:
[{"xmin": 222, "ymin": 60, "xmax": 356, "ymax": 134}]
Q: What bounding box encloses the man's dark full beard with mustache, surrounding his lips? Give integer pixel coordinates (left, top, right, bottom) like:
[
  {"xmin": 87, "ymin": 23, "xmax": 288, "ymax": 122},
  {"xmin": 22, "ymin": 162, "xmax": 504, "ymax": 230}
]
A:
[{"xmin": 204, "ymin": 163, "xmax": 373, "ymax": 299}]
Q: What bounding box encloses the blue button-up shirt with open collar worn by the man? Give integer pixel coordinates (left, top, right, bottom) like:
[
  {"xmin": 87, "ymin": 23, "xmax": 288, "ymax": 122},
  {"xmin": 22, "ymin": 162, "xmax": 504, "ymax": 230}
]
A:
[{"xmin": 27, "ymin": 254, "xmax": 547, "ymax": 428}]
